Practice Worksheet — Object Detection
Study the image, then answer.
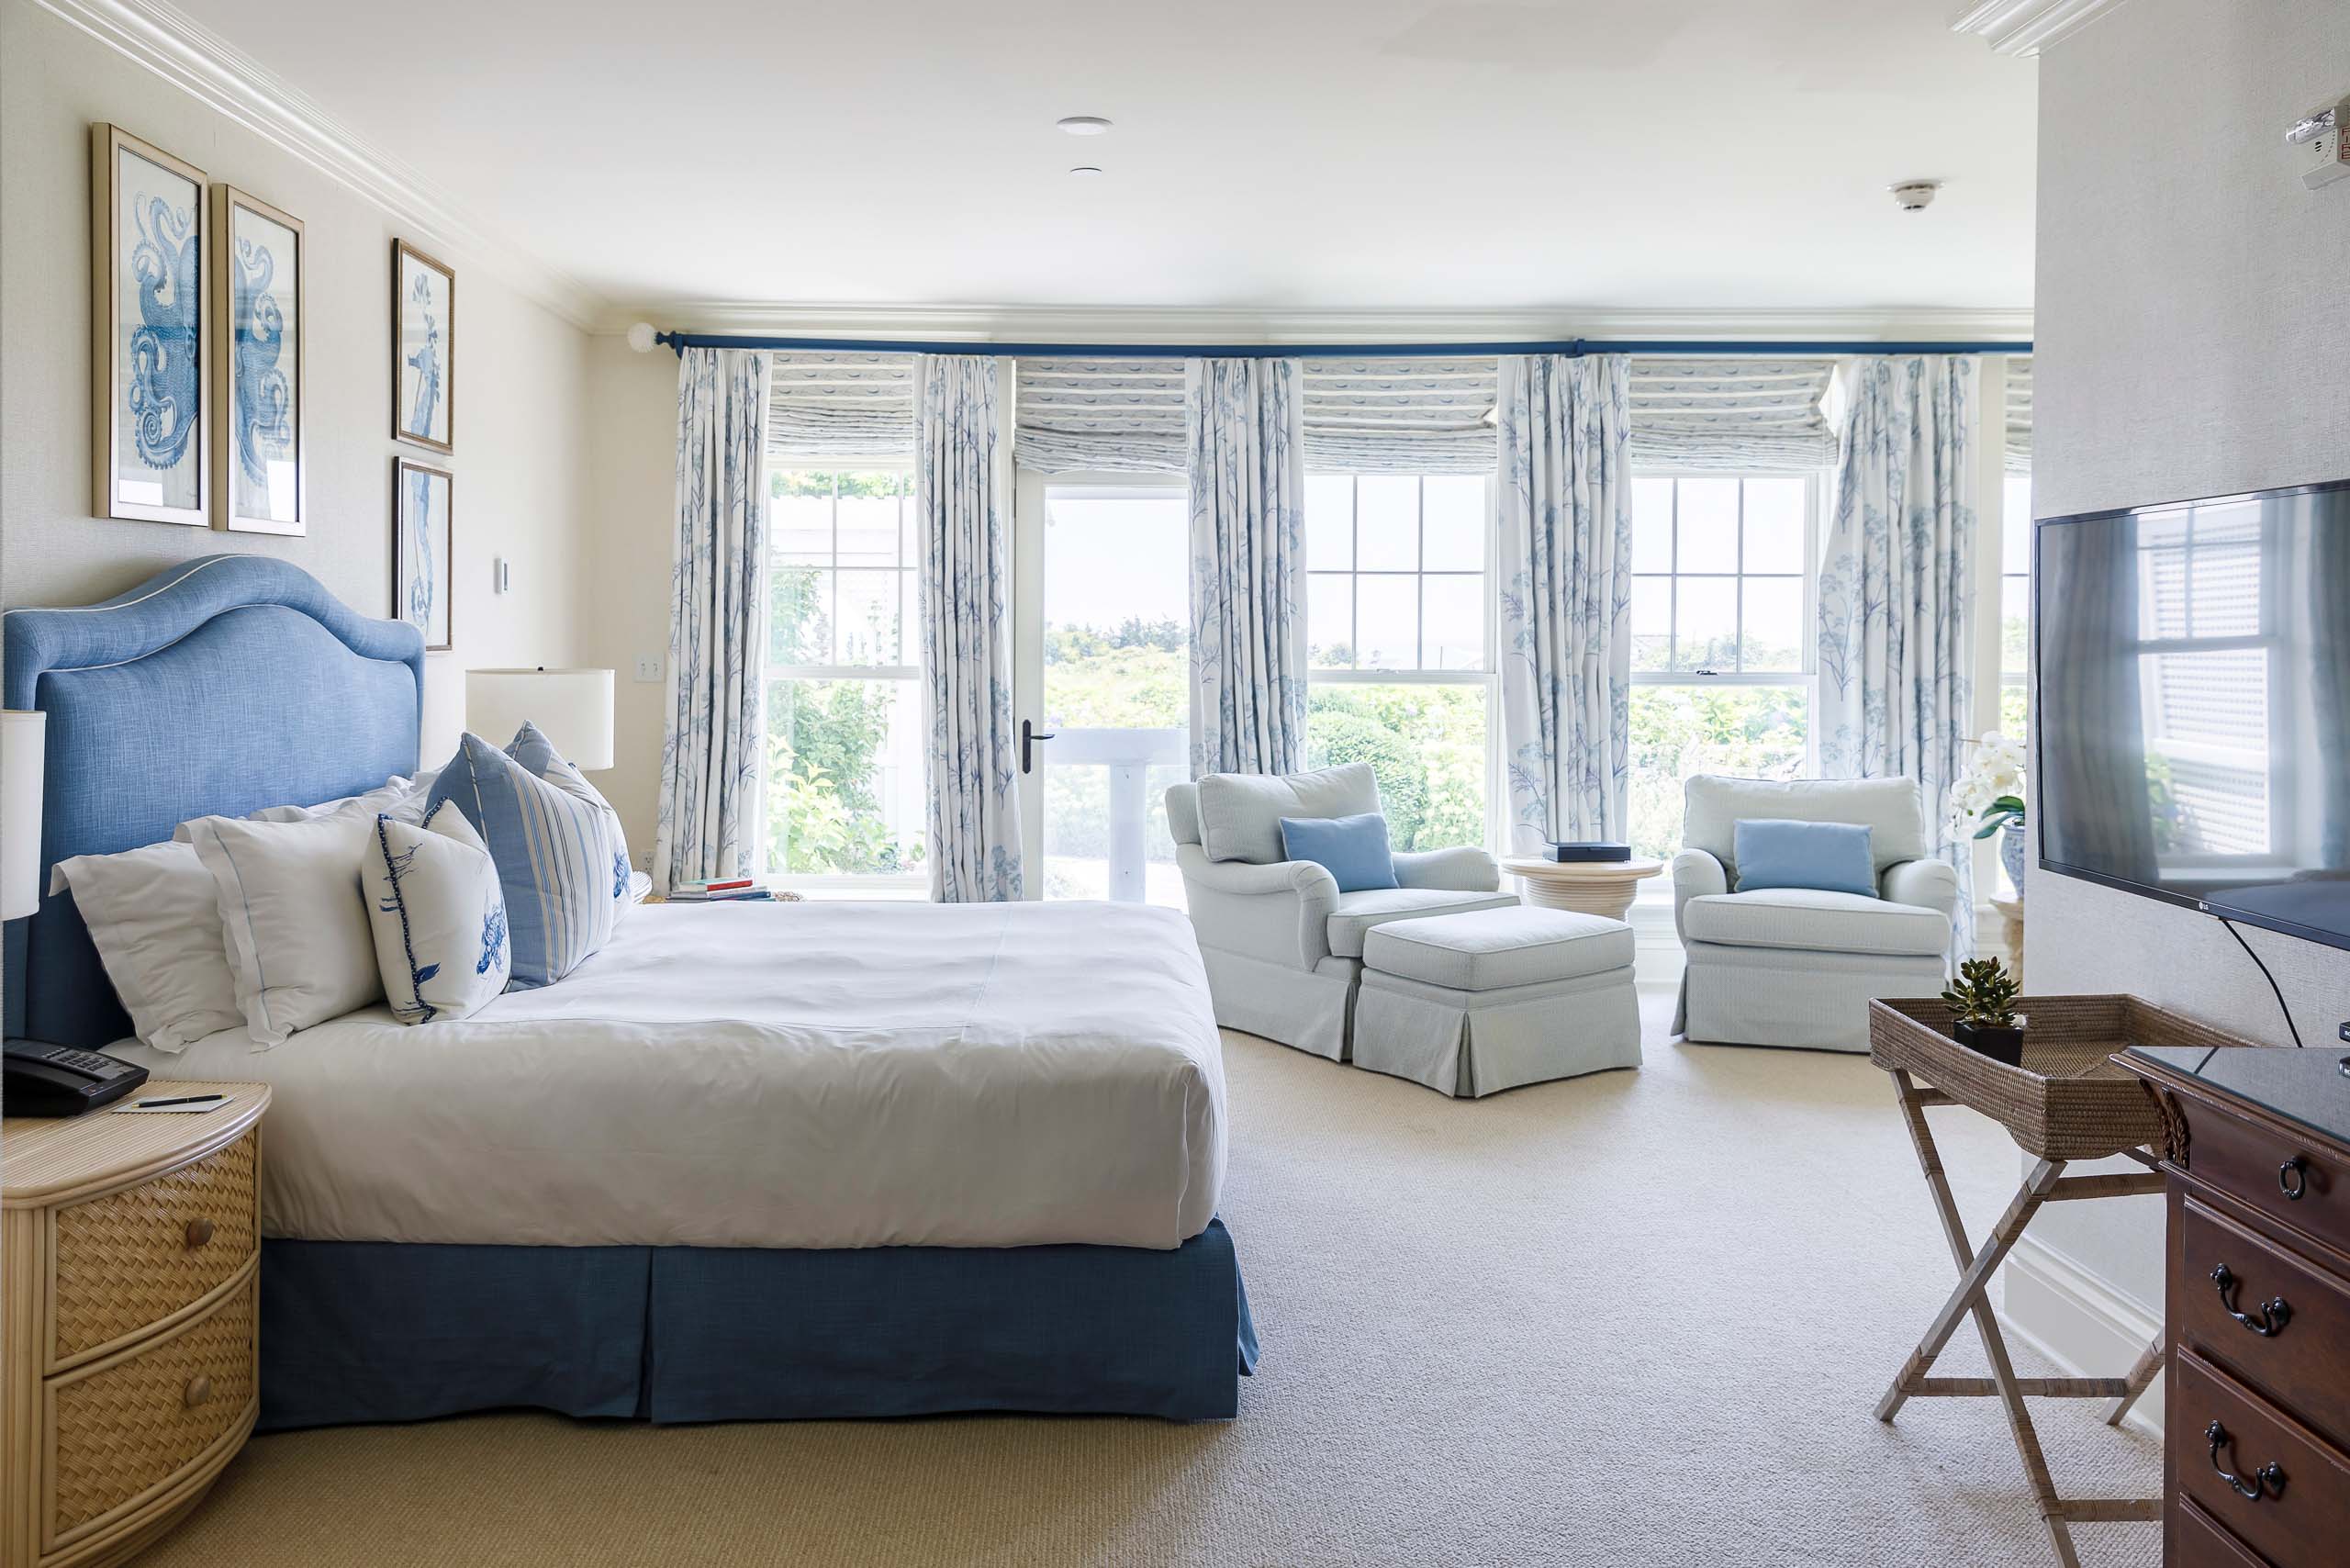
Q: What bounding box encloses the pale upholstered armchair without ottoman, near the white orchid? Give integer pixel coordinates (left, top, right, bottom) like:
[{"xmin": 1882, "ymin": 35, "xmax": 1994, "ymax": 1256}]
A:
[{"xmin": 1673, "ymin": 776, "xmax": 1957, "ymax": 1051}]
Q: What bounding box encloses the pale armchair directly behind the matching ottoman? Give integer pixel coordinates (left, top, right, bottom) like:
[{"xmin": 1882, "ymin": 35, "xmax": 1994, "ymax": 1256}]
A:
[{"xmin": 1166, "ymin": 762, "xmax": 1518, "ymax": 1062}]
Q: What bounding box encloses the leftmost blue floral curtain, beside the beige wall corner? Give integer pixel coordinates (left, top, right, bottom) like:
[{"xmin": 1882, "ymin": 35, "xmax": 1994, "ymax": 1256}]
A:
[{"xmin": 654, "ymin": 348, "xmax": 768, "ymax": 893}]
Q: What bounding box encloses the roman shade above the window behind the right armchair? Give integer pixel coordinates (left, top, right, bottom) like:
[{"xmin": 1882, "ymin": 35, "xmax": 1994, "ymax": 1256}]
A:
[{"xmin": 1628, "ymin": 355, "xmax": 1835, "ymax": 473}]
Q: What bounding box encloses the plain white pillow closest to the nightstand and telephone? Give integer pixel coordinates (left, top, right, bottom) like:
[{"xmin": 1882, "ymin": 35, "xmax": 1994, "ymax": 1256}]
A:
[{"xmin": 50, "ymin": 844, "xmax": 244, "ymax": 1051}]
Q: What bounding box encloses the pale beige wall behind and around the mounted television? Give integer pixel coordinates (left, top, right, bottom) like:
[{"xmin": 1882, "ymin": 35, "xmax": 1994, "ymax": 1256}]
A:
[{"xmin": 2026, "ymin": 0, "xmax": 2350, "ymax": 1312}]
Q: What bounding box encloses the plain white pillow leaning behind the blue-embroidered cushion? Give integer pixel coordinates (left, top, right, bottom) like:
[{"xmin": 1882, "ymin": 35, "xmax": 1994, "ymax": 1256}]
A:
[{"xmin": 188, "ymin": 811, "xmax": 383, "ymax": 1047}]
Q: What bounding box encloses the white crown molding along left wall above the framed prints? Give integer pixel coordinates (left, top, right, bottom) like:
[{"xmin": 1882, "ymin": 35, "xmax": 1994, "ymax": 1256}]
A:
[{"xmin": 35, "ymin": 0, "xmax": 609, "ymax": 331}]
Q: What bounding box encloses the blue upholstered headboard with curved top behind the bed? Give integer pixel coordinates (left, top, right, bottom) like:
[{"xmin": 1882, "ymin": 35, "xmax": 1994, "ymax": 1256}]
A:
[{"xmin": 0, "ymin": 554, "xmax": 425, "ymax": 1047}]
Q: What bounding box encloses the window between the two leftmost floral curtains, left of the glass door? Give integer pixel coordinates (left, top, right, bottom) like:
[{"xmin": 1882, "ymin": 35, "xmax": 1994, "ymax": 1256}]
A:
[{"xmin": 767, "ymin": 470, "xmax": 926, "ymax": 884}]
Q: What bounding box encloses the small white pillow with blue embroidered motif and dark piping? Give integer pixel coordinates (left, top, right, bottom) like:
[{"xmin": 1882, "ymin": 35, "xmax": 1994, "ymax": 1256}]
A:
[{"xmin": 360, "ymin": 801, "xmax": 512, "ymax": 1023}]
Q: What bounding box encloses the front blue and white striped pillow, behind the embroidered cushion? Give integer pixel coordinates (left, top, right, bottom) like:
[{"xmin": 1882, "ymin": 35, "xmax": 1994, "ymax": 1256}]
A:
[{"xmin": 425, "ymin": 734, "xmax": 625, "ymax": 990}]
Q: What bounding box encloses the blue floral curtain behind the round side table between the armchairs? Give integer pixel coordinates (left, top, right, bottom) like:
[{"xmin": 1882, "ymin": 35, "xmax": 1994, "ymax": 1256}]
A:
[{"xmin": 1499, "ymin": 355, "xmax": 1631, "ymax": 854}]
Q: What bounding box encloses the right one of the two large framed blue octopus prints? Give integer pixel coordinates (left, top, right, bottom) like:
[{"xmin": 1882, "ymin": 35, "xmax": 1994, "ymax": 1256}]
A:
[{"xmin": 211, "ymin": 184, "xmax": 310, "ymax": 533}]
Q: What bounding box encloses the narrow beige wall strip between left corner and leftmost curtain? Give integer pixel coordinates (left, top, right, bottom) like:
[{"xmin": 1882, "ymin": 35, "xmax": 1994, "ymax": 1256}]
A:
[{"xmin": 580, "ymin": 339, "xmax": 677, "ymax": 865}]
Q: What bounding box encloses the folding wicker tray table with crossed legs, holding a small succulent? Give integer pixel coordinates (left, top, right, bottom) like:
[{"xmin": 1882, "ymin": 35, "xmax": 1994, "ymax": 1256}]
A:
[{"xmin": 1868, "ymin": 997, "xmax": 2251, "ymax": 1568}]
